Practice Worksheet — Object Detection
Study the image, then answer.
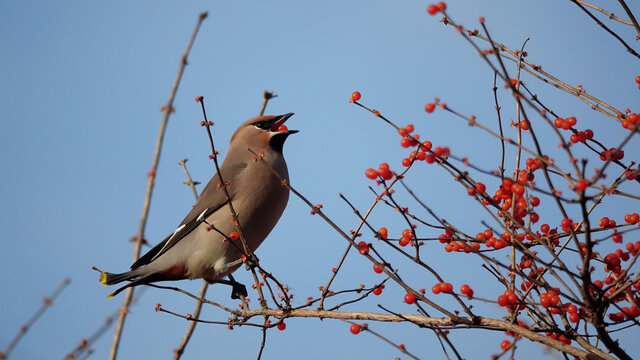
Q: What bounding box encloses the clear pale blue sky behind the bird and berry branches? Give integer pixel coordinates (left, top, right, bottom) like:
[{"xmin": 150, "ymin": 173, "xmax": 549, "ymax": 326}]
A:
[{"xmin": 0, "ymin": 0, "xmax": 640, "ymax": 359}]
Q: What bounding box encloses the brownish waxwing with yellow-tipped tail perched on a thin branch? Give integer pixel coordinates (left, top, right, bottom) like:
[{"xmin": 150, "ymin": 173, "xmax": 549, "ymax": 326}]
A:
[{"xmin": 94, "ymin": 113, "xmax": 298, "ymax": 298}]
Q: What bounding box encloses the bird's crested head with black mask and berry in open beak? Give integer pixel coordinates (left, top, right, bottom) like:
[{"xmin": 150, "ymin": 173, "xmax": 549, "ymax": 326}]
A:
[{"xmin": 230, "ymin": 113, "xmax": 298, "ymax": 153}]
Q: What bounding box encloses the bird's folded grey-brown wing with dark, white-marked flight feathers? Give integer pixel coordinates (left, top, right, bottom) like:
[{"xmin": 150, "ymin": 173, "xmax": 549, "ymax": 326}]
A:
[{"xmin": 131, "ymin": 163, "xmax": 247, "ymax": 269}]
